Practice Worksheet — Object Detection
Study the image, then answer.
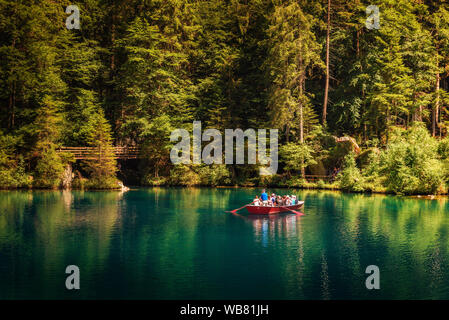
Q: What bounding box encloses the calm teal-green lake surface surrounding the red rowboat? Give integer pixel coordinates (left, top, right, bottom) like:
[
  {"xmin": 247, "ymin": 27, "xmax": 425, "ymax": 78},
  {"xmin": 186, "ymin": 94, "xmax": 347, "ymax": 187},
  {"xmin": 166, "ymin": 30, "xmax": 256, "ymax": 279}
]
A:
[{"xmin": 0, "ymin": 188, "xmax": 449, "ymax": 299}]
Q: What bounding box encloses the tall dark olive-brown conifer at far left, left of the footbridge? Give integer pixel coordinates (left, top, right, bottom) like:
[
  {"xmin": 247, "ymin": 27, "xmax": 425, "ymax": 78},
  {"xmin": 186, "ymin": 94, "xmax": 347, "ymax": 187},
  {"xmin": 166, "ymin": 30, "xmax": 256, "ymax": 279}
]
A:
[{"xmin": 0, "ymin": 0, "xmax": 73, "ymax": 188}]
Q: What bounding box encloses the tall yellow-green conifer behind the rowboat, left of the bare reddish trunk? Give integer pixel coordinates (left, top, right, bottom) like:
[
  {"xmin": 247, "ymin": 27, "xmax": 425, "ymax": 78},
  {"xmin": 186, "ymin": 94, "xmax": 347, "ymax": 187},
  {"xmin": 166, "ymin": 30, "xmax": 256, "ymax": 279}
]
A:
[{"xmin": 266, "ymin": 1, "xmax": 323, "ymax": 143}]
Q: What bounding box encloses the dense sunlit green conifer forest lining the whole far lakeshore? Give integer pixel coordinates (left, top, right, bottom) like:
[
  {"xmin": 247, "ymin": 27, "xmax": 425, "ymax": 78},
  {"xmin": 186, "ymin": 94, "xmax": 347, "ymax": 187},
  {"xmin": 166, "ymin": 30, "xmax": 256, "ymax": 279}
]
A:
[{"xmin": 0, "ymin": 0, "xmax": 449, "ymax": 194}]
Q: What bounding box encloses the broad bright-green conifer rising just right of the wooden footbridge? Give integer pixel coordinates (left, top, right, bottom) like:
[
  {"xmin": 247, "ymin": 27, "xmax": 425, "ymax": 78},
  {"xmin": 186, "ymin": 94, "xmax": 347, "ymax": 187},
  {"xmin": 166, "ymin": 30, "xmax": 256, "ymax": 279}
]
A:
[{"xmin": 117, "ymin": 0, "xmax": 199, "ymax": 132}]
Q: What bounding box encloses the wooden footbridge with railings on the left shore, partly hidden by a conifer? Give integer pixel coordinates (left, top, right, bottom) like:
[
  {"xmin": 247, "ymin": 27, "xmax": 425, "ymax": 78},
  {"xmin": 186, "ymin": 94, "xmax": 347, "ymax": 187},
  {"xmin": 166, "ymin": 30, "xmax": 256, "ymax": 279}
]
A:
[{"xmin": 57, "ymin": 147, "xmax": 140, "ymax": 160}]
